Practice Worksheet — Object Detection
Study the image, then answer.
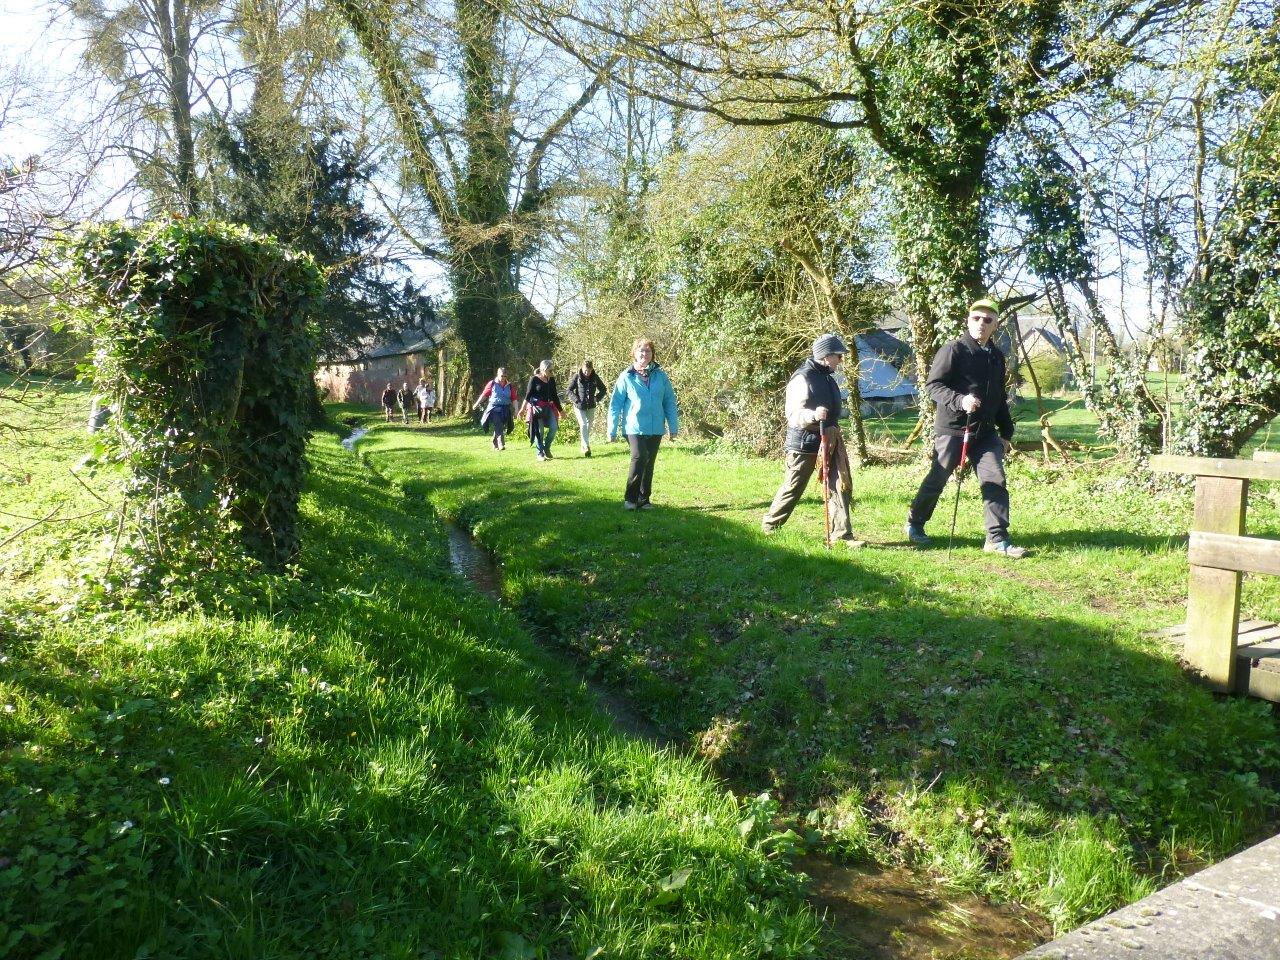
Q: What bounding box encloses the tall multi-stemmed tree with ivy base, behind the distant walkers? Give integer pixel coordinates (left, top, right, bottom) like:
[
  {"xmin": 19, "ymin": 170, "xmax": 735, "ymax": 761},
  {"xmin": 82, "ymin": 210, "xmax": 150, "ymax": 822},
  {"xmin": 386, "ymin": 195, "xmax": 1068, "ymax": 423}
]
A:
[{"xmin": 333, "ymin": 0, "xmax": 604, "ymax": 389}]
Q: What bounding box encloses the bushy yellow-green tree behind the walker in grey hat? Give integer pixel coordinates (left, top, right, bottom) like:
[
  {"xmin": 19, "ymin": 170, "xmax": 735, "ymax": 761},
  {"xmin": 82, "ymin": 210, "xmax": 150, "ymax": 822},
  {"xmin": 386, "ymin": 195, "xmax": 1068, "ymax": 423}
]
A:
[{"xmin": 650, "ymin": 124, "xmax": 884, "ymax": 461}]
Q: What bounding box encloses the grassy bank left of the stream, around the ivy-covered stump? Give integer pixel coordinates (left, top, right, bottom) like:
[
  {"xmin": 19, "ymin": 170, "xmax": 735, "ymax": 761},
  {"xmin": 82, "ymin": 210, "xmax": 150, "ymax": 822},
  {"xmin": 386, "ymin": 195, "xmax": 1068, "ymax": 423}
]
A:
[{"xmin": 0, "ymin": 385, "xmax": 818, "ymax": 960}]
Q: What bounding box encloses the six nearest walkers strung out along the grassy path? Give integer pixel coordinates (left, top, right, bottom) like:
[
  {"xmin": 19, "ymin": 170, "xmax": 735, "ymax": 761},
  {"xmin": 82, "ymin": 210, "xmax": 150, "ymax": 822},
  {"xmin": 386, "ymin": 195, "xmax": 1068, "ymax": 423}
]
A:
[{"xmin": 460, "ymin": 300, "xmax": 1027, "ymax": 558}]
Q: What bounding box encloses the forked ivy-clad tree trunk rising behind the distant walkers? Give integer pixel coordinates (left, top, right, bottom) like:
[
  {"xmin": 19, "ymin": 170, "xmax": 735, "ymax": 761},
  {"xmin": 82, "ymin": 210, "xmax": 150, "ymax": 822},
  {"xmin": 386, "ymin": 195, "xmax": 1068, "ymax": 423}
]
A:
[{"xmin": 330, "ymin": 0, "xmax": 600, "ymax": 392}]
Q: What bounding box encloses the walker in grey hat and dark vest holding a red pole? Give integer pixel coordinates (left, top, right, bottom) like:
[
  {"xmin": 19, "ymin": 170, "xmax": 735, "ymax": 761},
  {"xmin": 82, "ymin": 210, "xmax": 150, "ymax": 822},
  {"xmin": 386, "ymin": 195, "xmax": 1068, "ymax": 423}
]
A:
[{"xmin": 760, "ymin": 333, "xmax": 863, "ymax": 547}]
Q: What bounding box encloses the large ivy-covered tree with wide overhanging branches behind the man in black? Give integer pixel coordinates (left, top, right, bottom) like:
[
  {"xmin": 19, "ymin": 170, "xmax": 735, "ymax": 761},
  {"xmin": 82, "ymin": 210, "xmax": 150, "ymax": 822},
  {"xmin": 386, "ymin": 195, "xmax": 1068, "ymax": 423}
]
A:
[{"xmin": 529, "ymin": 0, "xmax": 1196, "ymax": 430}]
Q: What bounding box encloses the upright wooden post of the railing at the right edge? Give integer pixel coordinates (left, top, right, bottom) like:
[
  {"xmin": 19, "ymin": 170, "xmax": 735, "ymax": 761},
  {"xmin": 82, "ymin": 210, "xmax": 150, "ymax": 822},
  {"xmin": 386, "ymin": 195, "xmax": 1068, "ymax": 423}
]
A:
[{"xmin": 1183, "ymin": 476, "xmax": 1249, "ymax": 691}]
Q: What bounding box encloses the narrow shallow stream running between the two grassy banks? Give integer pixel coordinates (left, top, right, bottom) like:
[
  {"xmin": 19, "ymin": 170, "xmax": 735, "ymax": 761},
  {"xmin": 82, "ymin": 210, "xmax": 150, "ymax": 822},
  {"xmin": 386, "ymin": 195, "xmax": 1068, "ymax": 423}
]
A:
[{"xmin": 343, "ymin": 429, "xmax": 1051, "ymax": 960}]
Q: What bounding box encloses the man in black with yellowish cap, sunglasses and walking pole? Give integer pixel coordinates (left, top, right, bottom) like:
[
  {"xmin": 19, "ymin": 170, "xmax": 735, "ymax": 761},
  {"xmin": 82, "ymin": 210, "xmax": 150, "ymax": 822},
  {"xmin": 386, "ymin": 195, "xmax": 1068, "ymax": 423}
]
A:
[{"xmin": 905, "ymin": 300, "xmax": 1027, "ymax": 559}]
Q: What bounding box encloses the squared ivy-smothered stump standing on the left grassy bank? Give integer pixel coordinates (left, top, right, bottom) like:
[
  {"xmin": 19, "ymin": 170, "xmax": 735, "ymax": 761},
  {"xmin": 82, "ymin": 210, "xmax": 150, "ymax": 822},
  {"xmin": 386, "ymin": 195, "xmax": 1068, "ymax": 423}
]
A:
[{"xmin": 60, "ymin": 219, "xmax": 323, "ymax": 584}]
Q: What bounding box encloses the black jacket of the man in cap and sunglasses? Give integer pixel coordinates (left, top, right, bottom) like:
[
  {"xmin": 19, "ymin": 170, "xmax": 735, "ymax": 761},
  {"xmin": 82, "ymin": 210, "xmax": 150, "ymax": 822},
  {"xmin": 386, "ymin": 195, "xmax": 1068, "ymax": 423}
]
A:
[{"xmin": 925, "ymin": 333, "xmax": 1014, "ymax": 440}]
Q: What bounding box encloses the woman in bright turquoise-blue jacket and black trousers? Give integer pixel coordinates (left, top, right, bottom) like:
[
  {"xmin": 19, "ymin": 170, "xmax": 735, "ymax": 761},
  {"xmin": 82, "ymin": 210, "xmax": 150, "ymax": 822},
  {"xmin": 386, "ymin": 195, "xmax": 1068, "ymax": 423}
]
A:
[{"xmin": 609, "ymin": 339, "xmax": 680, "ymax": 509}]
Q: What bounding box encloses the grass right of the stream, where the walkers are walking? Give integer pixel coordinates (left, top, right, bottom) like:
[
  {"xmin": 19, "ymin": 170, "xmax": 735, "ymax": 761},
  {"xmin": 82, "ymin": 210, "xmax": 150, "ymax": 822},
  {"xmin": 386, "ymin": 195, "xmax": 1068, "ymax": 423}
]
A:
[{"xmin": 361, "ymin": 409, "xmax": 1280, "ymax": 929}]
